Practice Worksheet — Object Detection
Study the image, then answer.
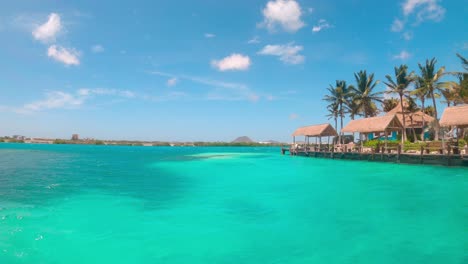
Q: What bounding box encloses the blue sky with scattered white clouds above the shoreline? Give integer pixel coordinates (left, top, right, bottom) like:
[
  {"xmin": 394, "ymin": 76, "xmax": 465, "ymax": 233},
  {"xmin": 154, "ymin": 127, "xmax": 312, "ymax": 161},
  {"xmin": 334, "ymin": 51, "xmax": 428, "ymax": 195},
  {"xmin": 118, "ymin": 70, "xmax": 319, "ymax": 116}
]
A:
[{"xmin": 0, "ymin": 0, "xmax": 468, "ymax": 141}]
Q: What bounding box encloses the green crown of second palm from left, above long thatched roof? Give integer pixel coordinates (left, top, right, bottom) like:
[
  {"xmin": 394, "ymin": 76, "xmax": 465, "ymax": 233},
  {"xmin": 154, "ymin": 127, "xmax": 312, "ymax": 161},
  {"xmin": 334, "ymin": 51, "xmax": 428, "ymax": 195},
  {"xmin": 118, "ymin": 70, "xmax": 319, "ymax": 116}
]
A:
[{"xmin": 350, "ymin": 71, "xmax": 382, "ymax": 118}]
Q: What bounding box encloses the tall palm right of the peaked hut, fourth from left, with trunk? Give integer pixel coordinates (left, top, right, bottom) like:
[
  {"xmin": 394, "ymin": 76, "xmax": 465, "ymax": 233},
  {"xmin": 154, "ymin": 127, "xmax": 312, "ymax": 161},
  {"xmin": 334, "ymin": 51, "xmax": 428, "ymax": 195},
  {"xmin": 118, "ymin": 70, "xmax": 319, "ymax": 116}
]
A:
[{"xmin": 418, "ymin": 58, "xmax": 445, "ymax": 140}]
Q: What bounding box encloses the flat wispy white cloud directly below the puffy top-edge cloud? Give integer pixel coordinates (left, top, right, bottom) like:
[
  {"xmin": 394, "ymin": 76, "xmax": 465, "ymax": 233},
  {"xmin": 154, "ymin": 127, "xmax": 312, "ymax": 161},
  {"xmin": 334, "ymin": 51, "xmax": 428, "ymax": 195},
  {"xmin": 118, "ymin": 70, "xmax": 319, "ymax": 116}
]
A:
[{"xmin": 258, "ymin": 43, "xmax": 305, "ymax": 64}]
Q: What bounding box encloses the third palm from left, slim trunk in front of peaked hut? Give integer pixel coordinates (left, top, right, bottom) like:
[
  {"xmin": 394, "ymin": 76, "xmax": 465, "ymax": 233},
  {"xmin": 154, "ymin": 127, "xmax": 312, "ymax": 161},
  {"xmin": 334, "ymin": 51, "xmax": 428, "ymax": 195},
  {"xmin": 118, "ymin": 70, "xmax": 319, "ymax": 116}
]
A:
[{"xmin": 384, "ymin": 64, "xmax": 412, "ymax": 142}]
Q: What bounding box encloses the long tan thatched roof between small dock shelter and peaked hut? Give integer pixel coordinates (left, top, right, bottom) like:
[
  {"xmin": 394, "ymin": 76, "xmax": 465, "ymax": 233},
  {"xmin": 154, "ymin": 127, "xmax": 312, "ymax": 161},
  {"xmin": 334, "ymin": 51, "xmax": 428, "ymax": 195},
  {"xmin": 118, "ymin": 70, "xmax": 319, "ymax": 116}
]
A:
[{"xmin": 341, "ymin": 115, "xmax": 403, "ymax": 133}]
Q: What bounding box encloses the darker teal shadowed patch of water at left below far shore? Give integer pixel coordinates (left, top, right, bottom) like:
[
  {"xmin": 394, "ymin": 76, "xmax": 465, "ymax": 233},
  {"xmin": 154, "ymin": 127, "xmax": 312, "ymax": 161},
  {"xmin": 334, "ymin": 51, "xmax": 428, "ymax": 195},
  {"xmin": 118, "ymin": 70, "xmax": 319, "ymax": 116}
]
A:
[{"xmin": 0, "ymin": 147, "xmax": 193, "ymax": 208}]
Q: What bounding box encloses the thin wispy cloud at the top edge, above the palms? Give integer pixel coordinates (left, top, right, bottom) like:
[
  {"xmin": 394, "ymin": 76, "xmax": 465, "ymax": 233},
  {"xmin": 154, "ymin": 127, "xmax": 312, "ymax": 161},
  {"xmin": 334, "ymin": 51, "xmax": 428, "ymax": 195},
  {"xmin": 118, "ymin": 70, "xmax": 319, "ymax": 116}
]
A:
[{"xmin": 403, "ymin": 0, "xmax": 445, "ymax": 22}]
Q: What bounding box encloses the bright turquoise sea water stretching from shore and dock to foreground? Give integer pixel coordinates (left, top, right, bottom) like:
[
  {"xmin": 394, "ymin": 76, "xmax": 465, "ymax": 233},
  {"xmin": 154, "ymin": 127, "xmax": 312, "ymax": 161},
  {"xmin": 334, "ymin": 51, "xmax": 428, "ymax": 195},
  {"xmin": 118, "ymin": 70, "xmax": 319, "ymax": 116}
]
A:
[{"xmin": 0, "ymin": 144, "xmax": 468, "ymax": 264}]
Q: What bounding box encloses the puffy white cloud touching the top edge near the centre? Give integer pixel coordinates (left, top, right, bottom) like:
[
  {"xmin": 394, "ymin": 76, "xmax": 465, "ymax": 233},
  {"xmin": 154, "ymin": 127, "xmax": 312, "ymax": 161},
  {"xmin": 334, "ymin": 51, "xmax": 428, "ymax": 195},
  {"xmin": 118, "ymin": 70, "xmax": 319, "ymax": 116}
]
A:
[{"xmin": 260, "ymin": 0, "xmax": 305, "ymax": 32}]
